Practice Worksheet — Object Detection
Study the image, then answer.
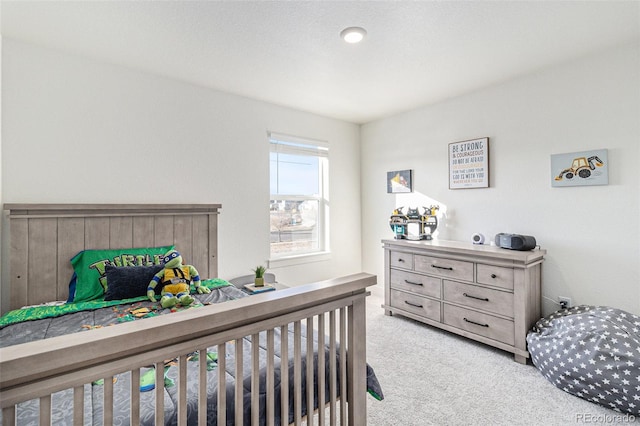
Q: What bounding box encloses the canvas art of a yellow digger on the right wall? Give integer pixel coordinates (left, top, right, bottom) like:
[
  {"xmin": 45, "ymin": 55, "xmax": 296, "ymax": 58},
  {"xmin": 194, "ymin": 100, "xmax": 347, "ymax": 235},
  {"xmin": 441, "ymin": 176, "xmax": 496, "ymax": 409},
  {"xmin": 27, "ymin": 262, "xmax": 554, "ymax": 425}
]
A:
[{"xmin": 551, "ymin": 149, "xmax": 609, "ymax": 187}]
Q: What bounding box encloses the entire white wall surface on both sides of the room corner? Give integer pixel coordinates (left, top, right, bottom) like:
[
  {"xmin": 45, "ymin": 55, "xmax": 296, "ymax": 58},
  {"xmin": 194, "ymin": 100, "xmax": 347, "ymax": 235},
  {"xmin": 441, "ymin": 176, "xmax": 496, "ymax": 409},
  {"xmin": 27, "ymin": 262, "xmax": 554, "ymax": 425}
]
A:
[{"xmin": 0, "ymin": 38, "xmax": 640, "ymax": 313}]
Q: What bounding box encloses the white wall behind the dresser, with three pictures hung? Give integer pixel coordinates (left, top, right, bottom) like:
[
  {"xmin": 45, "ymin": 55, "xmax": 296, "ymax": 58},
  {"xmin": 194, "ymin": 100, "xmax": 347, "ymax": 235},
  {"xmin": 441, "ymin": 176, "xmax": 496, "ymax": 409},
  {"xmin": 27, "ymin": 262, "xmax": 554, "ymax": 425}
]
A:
[{"xmin": 361, "ymin": 44, "xmax": 640, "ymax": 314}]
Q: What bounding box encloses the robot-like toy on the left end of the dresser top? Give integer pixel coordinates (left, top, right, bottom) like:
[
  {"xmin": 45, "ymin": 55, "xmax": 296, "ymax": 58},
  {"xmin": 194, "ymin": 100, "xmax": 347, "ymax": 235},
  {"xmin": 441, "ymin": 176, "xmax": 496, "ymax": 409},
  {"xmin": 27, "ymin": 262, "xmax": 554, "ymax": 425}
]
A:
[{"xmin": 389, "ymin": 205, "xmax": 440, "ymax": 240}]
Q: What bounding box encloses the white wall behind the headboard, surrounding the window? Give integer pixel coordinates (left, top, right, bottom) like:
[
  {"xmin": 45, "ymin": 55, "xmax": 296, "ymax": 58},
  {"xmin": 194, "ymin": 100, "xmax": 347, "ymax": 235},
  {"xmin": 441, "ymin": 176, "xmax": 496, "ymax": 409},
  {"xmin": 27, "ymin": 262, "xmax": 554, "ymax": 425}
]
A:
[{"xmin": 2, "ymin": 38, "xmax": 361, "ymax": 312}]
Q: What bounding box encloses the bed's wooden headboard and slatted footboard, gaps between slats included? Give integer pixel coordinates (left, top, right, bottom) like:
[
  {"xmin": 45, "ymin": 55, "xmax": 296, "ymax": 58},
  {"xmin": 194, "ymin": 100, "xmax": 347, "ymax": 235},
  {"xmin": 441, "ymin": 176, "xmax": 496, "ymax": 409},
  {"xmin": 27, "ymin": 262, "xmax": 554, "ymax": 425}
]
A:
[{"xmin": 0, "ymin": 204, "xmax": 376, "ymax": 425}]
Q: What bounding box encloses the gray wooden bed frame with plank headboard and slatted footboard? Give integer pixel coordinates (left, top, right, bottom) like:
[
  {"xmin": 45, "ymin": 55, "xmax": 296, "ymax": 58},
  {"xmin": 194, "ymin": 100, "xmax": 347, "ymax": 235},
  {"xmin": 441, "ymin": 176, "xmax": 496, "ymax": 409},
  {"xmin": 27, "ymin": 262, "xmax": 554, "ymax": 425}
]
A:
[{"xmin": 0, "ymin": 204, "xmax": 376, "ymax": 425}]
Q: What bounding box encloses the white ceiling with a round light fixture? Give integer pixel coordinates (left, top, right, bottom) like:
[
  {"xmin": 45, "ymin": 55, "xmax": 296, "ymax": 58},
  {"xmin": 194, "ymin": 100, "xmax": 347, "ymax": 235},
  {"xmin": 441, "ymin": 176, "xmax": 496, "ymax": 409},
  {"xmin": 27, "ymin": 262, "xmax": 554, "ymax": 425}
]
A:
[{"xmin": 0, "ymin": 0, "xmax": 640, "ymax": 123}]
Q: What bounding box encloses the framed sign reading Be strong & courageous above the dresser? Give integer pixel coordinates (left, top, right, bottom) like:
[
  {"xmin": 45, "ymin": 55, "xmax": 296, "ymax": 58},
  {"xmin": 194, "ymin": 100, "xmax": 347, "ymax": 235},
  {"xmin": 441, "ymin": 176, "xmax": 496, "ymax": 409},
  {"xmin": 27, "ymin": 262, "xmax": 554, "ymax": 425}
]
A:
[{"xmin": 449, "ymin": 138, "xmax": 489, "ymax": 189}]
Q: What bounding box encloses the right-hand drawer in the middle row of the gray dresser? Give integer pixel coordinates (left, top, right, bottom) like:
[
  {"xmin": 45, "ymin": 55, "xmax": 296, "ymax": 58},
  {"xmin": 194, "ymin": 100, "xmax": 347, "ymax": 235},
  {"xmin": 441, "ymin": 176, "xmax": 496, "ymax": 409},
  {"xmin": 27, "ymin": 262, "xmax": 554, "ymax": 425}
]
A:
[{"xmin": 443, "ymin": 280, "xmax": 513, "ymax": 318}]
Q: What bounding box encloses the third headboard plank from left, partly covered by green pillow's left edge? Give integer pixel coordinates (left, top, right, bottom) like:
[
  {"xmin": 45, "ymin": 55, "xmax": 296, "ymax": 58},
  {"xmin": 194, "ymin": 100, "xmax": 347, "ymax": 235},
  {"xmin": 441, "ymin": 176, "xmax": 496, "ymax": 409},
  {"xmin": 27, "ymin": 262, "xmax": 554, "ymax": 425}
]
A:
[{"xmin": 56, "ymin": 218, "xmax": 84, "ymax": 300}]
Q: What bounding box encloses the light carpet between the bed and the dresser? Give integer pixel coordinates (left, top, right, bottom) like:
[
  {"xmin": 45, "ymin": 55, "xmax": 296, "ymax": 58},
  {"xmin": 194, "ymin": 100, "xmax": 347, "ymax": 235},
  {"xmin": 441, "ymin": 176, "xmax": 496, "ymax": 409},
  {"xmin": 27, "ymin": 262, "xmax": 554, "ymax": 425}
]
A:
[{"xmin": 367, "ymin": 286, "xmax": 639, "ymax": 426}]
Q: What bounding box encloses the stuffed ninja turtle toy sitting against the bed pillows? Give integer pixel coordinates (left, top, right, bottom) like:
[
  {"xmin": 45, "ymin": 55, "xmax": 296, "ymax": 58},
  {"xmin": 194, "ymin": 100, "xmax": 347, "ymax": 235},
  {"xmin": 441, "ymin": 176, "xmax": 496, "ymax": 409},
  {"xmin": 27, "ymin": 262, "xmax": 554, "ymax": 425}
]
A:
[{"xmin": 147, "ymin": 250, "xmax": 211, "ymax": 308}]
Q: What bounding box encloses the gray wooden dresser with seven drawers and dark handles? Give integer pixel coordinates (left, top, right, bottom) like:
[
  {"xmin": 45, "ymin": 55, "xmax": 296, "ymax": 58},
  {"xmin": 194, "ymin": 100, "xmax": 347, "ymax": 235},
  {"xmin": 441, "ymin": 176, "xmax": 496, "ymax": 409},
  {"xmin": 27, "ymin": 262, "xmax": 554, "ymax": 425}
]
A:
[{"xmin": 382, "ymin": 240, "xmax": 546, "ymax": 364}]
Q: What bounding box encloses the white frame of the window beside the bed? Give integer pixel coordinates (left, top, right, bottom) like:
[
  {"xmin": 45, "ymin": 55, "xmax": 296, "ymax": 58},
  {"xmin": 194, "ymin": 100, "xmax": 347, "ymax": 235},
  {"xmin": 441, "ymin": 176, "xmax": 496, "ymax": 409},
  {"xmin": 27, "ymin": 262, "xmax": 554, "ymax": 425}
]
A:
[{"xmin": 267, "ymin": 132, "xmax": 330, "ymax": 268}]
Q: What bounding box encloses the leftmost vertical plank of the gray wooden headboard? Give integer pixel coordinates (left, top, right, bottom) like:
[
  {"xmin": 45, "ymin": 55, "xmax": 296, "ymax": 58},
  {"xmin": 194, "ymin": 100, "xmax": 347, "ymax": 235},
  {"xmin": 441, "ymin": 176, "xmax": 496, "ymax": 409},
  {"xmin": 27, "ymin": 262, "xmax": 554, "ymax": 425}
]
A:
[{"xmin": 9, "ymin": 219, "xmax": 29, "ymax": 309}]
